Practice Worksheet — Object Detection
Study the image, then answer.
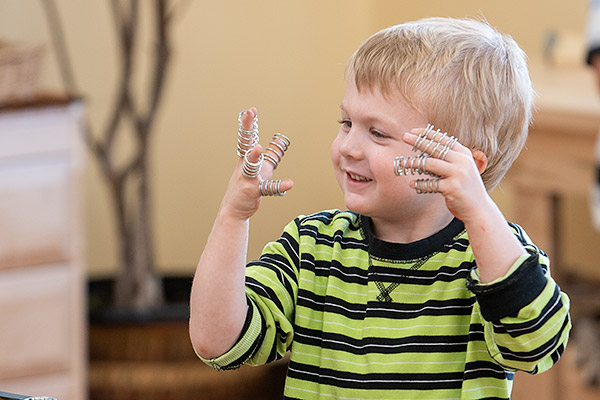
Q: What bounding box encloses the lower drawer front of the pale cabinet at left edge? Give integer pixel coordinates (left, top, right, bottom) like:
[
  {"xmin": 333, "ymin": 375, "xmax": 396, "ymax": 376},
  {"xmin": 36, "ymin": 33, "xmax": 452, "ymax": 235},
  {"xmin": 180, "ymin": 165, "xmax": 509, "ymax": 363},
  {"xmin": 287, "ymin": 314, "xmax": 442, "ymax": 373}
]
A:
[{"xmin": 0, "ymin": 264, "xmax": 76, "ymax": 380}]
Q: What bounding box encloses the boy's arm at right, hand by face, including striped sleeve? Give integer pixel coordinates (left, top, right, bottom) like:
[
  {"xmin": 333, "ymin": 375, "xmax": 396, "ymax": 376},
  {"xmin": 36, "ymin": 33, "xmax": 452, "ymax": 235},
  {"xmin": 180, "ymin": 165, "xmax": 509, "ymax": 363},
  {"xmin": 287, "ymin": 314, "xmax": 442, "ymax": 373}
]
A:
[{"xmin": 404, "ymin": 130, "xmax": 570, "ymax": 372}]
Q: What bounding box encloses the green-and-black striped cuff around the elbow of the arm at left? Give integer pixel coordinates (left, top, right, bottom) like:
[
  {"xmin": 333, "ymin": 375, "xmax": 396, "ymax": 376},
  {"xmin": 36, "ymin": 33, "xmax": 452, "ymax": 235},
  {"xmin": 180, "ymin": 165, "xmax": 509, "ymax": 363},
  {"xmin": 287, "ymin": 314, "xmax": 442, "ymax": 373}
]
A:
[{"xmin": 196, "ymin": 303, "xmax": 262, "ymax": 371}]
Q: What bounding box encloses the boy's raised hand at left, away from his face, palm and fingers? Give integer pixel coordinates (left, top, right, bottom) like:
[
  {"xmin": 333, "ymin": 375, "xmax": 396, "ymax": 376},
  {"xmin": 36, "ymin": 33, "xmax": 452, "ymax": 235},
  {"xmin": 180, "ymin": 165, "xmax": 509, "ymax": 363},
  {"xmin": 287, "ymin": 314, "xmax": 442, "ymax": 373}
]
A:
[{"xmin": 219, "ymin": 107, "xmax": 294, "ymax": 220}]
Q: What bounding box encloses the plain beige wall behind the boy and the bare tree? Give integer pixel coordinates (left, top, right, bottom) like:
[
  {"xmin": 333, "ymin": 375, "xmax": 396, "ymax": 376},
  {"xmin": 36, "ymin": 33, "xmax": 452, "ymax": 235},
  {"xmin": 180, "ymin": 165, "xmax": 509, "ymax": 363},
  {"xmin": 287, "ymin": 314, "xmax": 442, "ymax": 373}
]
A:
[{"xmin": 0, "ymin": 0, "xmax": 586, "ymax": 275}]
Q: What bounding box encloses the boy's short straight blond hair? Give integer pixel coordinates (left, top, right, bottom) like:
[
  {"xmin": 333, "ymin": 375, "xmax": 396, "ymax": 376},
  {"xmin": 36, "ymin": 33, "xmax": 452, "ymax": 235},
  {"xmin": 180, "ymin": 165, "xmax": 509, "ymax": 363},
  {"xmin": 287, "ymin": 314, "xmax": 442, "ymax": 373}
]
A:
[{"xmin": 347, "ymin": 18, "xmax": 535, "ymax": 190}]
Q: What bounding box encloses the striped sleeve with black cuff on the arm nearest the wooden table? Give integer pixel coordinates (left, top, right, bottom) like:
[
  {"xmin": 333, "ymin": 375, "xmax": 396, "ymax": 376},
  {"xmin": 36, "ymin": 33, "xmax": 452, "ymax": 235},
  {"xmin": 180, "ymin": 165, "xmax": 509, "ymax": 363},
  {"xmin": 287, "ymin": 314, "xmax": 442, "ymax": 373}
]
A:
[{"xmin": 468, "ymin": 224, "xmax": 571, "ymax": 373}]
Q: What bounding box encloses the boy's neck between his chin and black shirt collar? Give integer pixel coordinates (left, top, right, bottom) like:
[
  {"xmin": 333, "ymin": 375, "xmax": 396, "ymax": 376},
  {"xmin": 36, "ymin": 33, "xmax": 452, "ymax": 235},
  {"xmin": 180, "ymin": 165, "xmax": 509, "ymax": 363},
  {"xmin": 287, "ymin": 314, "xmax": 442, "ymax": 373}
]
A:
[{"xmin": 371, "ymin": 209, "xmax": 454, "ymax": 243}]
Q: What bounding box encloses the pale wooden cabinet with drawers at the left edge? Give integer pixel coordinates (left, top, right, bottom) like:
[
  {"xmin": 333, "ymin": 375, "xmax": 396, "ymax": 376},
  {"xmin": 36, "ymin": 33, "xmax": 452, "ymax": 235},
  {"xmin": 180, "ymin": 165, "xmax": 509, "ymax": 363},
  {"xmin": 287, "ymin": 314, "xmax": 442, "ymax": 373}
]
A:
[{"xmin": 0, "ymin": 97, "xmax": 86, "ymax": 400}]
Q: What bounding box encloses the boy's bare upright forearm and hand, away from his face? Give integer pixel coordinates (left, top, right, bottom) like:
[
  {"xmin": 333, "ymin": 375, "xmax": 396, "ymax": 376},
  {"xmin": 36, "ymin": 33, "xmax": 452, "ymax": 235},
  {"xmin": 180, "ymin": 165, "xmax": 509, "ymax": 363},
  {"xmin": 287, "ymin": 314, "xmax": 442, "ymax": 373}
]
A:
[{"xmin": 190, "ymin": 109, "xmax": 293, "ymax": 358}]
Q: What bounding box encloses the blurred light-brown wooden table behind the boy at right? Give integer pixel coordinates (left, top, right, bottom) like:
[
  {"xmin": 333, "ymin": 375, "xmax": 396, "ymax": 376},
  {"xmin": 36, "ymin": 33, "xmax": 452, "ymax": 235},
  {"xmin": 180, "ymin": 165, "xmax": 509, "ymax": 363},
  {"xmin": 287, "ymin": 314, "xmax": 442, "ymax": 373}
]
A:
[{"xmin": 504, "ymin": 64, "xmax": 600, "ymax": 400}]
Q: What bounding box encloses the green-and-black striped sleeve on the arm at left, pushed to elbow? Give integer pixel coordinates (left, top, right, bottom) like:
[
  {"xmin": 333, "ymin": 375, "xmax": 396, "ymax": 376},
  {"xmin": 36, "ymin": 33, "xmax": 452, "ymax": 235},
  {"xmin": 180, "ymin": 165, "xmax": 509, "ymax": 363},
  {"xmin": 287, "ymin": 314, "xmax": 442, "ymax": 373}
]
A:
[{"xmin": 200, "ymin": 218, "xmax": 300, "ymax": 370}]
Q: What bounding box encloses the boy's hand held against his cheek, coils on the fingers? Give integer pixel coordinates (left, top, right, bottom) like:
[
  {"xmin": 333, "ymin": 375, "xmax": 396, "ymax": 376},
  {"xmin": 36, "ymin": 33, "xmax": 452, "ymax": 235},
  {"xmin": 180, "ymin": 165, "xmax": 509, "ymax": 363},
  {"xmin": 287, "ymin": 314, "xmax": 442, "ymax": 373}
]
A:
[{"xmin": 403, "ymin": 128, "xmax": 489, "ymax": 222}]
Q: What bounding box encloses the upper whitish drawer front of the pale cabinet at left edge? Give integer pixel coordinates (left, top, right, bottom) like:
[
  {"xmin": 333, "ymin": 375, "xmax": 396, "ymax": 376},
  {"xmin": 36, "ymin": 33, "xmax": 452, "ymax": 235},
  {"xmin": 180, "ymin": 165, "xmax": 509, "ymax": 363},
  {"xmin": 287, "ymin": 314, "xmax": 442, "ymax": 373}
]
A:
[{"xmin": 0, "ymin": 156, "xmax": 73, "ymax": 270}]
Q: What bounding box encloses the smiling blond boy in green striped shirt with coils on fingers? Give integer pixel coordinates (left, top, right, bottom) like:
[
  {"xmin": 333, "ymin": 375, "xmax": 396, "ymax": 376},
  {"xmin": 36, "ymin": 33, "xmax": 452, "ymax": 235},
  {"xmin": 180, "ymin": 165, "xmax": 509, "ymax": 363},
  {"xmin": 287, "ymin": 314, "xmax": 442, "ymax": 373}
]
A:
[{"xmin": 190, "ymin": 18, "xmax": 570, "ymax": 399}]
